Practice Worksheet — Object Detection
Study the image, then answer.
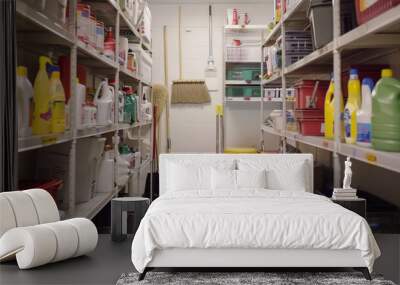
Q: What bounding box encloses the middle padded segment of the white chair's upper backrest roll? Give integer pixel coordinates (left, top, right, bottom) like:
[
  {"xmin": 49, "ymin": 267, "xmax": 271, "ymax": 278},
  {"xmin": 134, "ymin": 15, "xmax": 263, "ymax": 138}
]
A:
[{"xmin": 23, "ymin": 189, "xmax": 60, "ymax": 224}]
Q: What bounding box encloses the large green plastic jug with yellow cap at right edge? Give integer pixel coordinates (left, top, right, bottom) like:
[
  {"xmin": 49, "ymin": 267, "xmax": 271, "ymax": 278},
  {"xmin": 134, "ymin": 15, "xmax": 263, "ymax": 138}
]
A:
[{"xmin": 371, "ymin": 69, "xmax": 400, "ymax": 152}]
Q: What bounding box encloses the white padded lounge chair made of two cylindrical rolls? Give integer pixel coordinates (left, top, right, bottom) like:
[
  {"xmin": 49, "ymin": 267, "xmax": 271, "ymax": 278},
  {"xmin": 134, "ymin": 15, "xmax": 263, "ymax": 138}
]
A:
[{"xmin": 0, "ymin": 189, "xmax": 98, "ymax": 269}]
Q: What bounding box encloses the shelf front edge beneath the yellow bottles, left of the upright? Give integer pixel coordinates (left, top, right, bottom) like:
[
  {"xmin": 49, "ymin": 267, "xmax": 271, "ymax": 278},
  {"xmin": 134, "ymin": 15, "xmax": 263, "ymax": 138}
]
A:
[{"xmin": 18, "ymin": 131, "xmax": 72, "ymax": 152}]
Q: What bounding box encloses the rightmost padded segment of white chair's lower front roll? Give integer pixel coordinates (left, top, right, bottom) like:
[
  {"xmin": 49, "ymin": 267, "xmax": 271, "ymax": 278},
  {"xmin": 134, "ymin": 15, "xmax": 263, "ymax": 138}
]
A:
[{"xmin": 65, "ymin": 218, "xmax": 98, "ymax": 257}]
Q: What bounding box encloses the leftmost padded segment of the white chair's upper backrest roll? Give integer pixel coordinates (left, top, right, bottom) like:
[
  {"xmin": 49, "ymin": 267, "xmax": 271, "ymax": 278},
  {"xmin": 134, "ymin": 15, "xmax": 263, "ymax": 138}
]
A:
[{"xmin": 2, "ymin": 191, "xmax": 39, "ymax": 227}]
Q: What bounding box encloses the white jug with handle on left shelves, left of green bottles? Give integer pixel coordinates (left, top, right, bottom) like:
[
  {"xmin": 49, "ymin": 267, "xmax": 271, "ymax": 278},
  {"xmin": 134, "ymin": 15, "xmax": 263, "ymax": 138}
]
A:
[{"xmin": 94, "ymin": 78, "xmax": 114, "ymax": 126}]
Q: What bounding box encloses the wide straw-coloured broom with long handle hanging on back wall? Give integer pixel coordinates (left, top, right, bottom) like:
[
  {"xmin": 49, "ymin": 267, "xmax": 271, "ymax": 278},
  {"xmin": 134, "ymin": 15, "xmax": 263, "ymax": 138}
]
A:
[{"xmin": 171, "ymin": 6, "xmax": 211, "ymax": 104}]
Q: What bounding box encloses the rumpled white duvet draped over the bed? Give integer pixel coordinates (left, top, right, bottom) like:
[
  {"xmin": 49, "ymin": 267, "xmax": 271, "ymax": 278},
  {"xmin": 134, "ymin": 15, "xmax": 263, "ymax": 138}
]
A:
[{"xmin": 132, "ymin": 189, "xmax": 380, "ymax": 272}]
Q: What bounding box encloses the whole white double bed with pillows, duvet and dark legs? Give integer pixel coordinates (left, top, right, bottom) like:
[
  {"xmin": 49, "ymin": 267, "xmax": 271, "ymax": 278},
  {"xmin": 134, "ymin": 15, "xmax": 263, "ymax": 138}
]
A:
[{"xmin": 132, "ymin": 154, "xmax": 380, "ymax": 278}]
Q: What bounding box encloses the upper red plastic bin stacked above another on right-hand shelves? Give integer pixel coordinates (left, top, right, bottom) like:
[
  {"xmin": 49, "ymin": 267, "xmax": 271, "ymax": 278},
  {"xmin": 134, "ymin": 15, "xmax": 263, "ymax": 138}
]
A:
[{"xmin": 295, "ymin": 80, "xmax": 329, "ymax": 110}]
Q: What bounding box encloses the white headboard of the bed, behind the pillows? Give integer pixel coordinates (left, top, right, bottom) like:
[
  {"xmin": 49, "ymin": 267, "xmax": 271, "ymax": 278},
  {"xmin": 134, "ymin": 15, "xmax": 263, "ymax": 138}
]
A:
[{"xmin": 159, "ymin": 153, "xmax": 314, "ymax": 195}]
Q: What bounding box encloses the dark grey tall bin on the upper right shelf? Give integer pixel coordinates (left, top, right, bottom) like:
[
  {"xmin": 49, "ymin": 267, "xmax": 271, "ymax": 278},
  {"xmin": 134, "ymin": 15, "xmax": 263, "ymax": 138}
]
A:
[{"xmin": 308, "ymin": 0, "xmax": 333, "ymax": 49}]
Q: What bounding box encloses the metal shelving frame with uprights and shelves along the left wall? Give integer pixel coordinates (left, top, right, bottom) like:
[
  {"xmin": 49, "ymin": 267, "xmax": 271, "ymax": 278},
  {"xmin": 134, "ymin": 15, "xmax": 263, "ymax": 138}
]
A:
[{"xmin": 16, "ymin": 0, "xmax": 153, "ymax": 218}]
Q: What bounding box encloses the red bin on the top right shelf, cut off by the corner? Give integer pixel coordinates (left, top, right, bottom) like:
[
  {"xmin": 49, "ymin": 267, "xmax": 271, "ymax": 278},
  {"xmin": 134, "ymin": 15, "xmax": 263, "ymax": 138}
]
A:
[{"xmin": 355, "ymin": 0, "xmax": 400, "ymax": 25}]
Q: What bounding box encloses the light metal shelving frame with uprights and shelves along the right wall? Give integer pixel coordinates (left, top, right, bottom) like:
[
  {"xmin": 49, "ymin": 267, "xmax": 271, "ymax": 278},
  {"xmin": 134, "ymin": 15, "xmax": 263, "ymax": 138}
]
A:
[{"xmin": 260, "ymin": 0, "xmax": 400, "ymax": 181}]
